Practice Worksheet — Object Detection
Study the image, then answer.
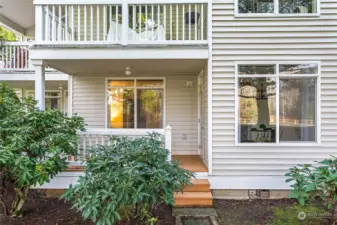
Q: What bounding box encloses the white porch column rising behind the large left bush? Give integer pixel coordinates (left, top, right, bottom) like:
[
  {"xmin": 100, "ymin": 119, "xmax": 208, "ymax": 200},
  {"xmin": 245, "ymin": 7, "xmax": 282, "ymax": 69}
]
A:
[{"xmin": 32, "ymin": 60, "xmax": 46, "ymax": 110}]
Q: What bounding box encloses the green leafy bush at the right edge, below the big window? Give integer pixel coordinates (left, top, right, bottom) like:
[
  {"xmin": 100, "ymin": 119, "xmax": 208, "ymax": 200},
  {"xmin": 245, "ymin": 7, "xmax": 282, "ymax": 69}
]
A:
[{"xmin": 286, "ymin": 157, "xmax": 337, "ymax": 217}]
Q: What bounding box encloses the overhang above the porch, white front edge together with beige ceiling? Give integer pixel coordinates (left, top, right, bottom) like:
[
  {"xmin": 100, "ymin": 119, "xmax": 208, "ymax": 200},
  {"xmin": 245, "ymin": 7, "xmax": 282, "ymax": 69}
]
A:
[{"xmin": 31, "ymin": 49, "xmax": 207, "ymax": 76}]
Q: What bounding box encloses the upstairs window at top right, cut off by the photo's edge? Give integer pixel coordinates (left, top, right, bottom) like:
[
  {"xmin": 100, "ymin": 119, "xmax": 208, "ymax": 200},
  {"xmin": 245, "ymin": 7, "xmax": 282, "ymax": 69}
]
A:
[{"xmin": 237, "ymin": 0, "xmax": 319, "ymax": 15}]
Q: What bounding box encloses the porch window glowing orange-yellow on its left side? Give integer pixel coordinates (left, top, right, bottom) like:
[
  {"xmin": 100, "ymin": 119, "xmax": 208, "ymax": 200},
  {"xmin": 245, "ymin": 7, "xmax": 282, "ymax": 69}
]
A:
[{"xmin": 107, "ymin": 79, "xmax": 164, "ymax": 128}]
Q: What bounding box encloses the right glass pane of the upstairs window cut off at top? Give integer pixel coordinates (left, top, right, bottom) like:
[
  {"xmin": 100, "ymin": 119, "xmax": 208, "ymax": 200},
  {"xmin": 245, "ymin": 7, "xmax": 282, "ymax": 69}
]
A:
[{"xmin": 279, "ymin": 0, "xmax": 317, "ymax": 14}]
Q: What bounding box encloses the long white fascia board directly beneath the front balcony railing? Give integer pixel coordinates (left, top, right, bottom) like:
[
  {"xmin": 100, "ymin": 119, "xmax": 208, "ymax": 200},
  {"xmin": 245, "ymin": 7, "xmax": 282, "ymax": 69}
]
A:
[{"xmin": 30, "ymin": 48, "xmax": 208, "ymax": 60}]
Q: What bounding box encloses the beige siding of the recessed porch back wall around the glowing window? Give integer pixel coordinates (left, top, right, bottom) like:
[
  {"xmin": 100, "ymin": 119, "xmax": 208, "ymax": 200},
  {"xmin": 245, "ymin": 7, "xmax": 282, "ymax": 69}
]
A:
[{"xmin": 73, "ymin": 74, "xmax": 198, "ymax": 154}]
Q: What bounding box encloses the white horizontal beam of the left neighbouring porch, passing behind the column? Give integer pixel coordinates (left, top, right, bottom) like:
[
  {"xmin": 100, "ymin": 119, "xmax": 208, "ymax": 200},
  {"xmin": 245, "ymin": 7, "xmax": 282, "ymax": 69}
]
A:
[{"xmin": 0, "ymin": 73, "xmax": 69, "ymax": 82}]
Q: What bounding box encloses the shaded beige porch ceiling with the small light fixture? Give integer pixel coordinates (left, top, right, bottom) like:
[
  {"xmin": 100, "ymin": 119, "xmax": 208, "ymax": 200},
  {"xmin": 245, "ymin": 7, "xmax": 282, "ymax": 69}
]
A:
[{"xmin": 48, "ymin": 59, "xmax": 207, "ymax": 76}]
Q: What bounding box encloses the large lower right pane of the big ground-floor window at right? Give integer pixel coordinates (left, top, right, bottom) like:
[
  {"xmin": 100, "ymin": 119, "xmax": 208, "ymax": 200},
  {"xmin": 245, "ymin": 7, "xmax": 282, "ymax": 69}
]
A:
[{"xmin": 280, "ymin": 78, "xmax": 316, "ymax": 142}]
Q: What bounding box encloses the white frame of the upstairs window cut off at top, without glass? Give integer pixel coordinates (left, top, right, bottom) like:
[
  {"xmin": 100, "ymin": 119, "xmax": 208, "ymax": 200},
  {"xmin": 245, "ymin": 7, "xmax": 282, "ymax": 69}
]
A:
[{"xmin": 234, "ymin": 0, "xmax": 321, "ymax": 17}]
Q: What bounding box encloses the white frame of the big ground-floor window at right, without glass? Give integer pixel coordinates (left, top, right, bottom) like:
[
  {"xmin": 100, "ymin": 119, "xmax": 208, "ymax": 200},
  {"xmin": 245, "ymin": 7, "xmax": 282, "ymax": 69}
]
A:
[{"xmin": 234, "ymin": 61, "xmax": 321, "ymax": 147}]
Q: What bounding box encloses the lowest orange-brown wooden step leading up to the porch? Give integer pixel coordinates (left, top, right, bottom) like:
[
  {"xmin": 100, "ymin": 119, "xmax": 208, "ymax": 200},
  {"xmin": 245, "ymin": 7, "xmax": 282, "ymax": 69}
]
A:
[{"xmin": 174, "ymin": 192, "xmax": 213, "ymax": 207}]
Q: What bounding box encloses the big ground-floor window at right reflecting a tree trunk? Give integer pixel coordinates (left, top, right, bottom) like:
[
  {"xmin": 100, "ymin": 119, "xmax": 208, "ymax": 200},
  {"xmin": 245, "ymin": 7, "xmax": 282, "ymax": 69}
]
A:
[{"xmin": 236, "ymin": 63, "xmax": 319, "ymax": 143}]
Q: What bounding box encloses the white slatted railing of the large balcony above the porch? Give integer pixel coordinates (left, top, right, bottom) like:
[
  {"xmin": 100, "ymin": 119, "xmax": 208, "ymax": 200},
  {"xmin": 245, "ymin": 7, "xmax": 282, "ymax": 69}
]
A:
[{"xmin": 36, "ymin": 0, "xmax": 208, "ymax": 45}]
